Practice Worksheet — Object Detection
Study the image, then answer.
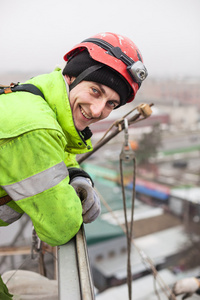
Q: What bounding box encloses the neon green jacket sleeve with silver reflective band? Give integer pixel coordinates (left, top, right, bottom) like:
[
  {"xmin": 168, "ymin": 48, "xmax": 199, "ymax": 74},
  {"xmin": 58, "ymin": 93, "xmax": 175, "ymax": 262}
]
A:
[{"xmin": 0, "ymin": 129, "xmax": 82, "ymax": 246}]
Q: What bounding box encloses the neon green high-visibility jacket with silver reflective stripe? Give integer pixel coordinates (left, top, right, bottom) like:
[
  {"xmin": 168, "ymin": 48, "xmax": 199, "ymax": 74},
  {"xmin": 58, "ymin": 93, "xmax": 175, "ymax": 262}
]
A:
[{"xmin": 0, "ymin": 69, "xmax": 92, "ymax": 246}]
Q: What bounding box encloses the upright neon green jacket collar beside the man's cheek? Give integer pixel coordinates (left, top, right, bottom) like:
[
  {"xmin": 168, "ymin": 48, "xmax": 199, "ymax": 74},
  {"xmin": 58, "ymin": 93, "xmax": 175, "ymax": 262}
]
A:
[{"xmin": 27, "ymin": 68, "xmax": 92, "ymax": 154}]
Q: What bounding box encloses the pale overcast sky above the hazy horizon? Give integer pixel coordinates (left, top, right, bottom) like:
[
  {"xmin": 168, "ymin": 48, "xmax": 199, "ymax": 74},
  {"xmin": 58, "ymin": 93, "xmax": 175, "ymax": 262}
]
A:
[{"xmin": 0, "ymin": 0, "xmax": 200, "ymax": 77}]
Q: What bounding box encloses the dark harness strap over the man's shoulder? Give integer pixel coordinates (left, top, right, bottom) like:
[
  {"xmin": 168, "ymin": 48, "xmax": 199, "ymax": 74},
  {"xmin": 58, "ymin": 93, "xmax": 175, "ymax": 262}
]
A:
[{"xmin": 0, "ymin": 83, "xmax": 45, "ymax": 99}]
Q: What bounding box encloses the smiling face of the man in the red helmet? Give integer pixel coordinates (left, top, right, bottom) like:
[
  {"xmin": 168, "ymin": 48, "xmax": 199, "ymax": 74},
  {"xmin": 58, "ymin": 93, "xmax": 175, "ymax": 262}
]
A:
[{"xmin": 69, "ymin": 81, "xmax": 120, "ymax": 131}]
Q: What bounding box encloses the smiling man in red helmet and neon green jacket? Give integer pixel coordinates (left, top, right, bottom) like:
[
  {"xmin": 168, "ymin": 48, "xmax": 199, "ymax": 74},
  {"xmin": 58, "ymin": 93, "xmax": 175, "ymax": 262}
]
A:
[{"xmin": 0, "ymin": 33, "xmax": 147, "ymax": 298}]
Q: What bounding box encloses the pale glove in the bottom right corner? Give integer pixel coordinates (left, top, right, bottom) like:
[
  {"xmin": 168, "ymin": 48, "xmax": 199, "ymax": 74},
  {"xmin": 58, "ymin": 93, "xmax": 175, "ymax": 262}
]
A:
[{"xmin": 172, "ymin": 277, "xmax": 200, "ymax": 299}]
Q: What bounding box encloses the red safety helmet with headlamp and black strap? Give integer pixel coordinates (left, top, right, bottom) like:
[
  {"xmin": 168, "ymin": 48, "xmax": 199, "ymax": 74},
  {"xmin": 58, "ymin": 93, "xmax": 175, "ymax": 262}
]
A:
[{"xmin": 64, "ymin": 32, "xmax": 148, "ymax": 102}]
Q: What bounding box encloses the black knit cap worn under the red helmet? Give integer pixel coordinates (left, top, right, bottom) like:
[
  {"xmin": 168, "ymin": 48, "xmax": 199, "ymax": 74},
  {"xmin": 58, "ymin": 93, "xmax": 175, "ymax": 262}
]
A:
[{"xmin": 63, "ymin": 50, "xmax": 131, "ymax": 107}]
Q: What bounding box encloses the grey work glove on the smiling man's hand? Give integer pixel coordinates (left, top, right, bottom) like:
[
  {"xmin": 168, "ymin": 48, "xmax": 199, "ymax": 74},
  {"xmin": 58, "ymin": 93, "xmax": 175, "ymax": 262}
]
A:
[{"xmin": 70, "ymin": 176, "xmax": 101, "ymax": 223}]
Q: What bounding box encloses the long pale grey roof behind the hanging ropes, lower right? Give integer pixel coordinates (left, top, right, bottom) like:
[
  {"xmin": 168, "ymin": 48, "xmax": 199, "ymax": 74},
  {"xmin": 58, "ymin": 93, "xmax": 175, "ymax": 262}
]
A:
[{"xmin": 91, "ymin": 226, "xmax": 188, "ymax": 279}]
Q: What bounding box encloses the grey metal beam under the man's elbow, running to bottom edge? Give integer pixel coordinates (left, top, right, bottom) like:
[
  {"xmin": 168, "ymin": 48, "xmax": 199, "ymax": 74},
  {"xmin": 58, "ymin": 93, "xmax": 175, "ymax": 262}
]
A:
[{"xmin": 57, "ymin": 225, "xmax": 95, "ymax": 300}]
